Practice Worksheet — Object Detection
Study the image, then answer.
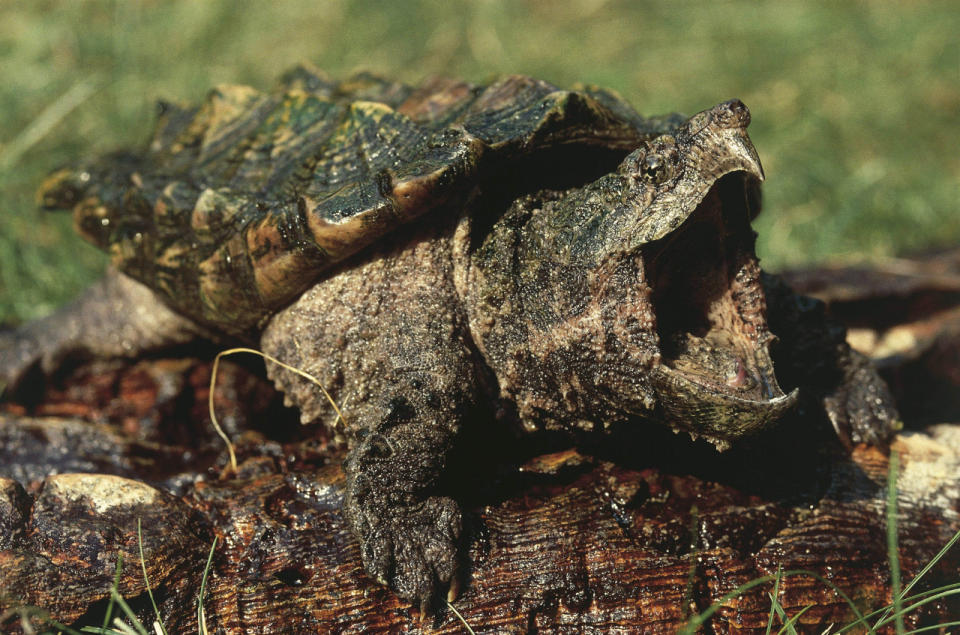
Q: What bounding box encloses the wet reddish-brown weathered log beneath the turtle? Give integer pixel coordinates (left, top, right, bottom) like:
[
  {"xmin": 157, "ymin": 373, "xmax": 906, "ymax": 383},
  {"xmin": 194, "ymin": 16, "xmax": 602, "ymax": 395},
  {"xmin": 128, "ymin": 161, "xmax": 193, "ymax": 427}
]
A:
[{"xmin": 0, "ymin": 251, "xmax": 960, "ymax": 633}]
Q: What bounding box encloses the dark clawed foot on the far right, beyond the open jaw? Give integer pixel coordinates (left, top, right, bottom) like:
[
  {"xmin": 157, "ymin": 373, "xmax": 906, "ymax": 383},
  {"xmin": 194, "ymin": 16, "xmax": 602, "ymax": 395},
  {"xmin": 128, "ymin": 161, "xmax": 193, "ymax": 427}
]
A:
[{"xmin": 824, "ymin": 352, "xmax": 903, "ymax": 447}]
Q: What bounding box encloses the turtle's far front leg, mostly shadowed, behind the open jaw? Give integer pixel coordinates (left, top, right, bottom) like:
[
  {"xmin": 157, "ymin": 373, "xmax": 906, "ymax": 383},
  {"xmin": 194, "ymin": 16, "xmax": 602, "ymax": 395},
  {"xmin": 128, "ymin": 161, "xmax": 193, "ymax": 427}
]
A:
[{"xmin": 764, "ymin": 275, "xmax": 902, "ymax": 447}]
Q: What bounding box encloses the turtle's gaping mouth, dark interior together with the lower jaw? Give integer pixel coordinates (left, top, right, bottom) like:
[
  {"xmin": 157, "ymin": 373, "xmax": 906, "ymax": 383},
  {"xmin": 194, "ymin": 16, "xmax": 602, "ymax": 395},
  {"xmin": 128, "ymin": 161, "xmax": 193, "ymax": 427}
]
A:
[{"xmin": 644, "ymin": 172, "xmax": 796, "ymax": 446}]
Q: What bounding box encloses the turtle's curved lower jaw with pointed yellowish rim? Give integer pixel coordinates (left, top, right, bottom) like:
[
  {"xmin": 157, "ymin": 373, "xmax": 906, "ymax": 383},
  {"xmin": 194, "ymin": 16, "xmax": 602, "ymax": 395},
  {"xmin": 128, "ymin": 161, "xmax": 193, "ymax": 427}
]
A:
[{"xmin": 652, "ymin": 365, "xmax": 798, "ymax": 450}]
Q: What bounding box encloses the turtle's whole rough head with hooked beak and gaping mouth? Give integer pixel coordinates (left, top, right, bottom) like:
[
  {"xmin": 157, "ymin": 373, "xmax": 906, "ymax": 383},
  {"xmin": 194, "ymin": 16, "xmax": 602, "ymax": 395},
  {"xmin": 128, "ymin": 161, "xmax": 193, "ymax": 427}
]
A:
[{"xmin": 475, "ymin": 100, "xmax": 796, "ymax": 448}]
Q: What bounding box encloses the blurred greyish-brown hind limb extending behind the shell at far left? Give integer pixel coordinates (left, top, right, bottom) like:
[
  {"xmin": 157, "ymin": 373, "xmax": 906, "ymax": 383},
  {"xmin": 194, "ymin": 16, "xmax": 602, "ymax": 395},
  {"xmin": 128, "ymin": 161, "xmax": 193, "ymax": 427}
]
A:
[{"xmin": 0, "ymin": 270, "xmax": 204, "ymax": 391}]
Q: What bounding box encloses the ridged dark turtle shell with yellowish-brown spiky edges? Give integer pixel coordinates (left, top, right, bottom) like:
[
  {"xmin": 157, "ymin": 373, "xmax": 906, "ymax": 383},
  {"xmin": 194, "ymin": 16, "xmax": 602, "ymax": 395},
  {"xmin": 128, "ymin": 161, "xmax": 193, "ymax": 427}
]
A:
[{"xmin": 40, "ymin": 67, "xmax": 679, "ymax": 334}]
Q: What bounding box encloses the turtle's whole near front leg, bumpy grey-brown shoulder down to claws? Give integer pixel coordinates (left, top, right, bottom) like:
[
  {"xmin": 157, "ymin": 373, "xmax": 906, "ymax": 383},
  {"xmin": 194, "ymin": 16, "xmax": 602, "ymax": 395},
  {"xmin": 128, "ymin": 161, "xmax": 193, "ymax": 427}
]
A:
[{"xmin": 261, "ymin": 218, "xmax": 480, "ymax": 607}]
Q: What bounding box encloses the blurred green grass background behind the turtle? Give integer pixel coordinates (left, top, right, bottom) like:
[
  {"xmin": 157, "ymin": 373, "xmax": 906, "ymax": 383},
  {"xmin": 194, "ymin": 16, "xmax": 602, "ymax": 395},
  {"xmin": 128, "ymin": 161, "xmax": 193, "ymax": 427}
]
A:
[{"xmin": 0, "ymin": 0, "xmax": 960, "ymax": 325}]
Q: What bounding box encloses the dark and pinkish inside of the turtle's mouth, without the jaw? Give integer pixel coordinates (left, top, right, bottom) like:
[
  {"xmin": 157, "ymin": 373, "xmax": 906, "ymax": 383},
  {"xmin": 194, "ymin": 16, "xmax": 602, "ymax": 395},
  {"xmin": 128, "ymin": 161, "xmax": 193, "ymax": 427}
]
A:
[{"xmin": 644, "ymin": 173, "xmax": 782, "ymax": 400}]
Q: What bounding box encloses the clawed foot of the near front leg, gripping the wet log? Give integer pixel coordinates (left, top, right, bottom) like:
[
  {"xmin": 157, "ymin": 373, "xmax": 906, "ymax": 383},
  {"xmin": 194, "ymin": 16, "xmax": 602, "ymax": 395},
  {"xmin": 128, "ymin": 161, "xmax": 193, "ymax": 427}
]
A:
[{"xmin": 361, "ymin": 497, "xmax": 461, "ymax": 609}]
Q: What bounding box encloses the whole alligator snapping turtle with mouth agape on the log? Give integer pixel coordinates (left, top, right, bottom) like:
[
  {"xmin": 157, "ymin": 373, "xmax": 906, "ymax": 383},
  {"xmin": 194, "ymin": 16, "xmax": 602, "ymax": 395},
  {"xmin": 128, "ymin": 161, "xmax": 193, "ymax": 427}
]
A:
[{"xmin": 0, "ymin": 68, "xmax": 897, "ymax": 601}]
